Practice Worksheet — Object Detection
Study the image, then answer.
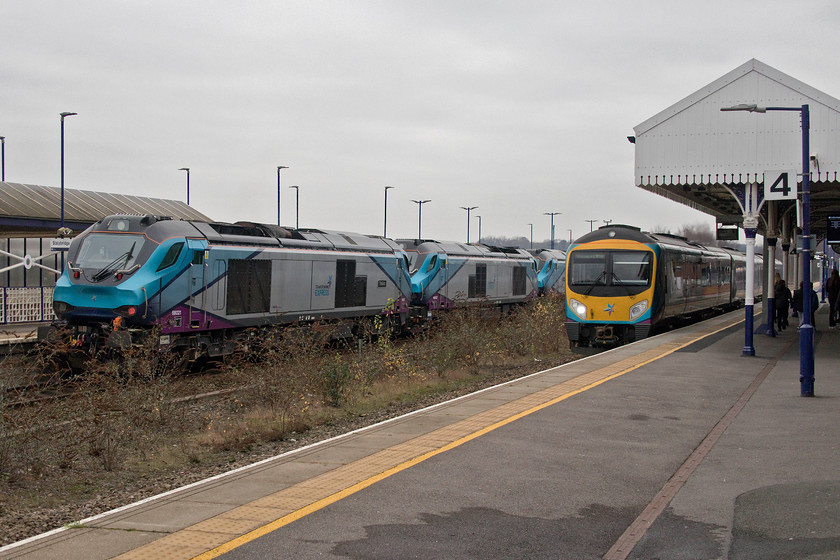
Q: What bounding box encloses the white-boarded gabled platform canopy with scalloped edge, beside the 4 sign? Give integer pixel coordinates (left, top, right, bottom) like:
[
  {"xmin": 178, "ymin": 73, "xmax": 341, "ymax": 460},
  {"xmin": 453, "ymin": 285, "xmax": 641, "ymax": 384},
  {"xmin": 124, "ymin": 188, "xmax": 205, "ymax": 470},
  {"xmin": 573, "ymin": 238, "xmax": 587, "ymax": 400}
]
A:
[{"xmin": 628, "ymin": 59, "xmax": 840, "ymax": 239}]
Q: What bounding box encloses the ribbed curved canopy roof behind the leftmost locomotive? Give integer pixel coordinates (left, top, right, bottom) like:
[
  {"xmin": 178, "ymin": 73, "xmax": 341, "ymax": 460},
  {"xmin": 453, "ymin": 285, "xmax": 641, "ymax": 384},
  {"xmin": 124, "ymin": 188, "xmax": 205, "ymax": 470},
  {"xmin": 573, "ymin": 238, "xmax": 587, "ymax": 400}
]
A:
[{"xmin": 0, "ymin": 182, "xmax": 212, "ymax": 237}]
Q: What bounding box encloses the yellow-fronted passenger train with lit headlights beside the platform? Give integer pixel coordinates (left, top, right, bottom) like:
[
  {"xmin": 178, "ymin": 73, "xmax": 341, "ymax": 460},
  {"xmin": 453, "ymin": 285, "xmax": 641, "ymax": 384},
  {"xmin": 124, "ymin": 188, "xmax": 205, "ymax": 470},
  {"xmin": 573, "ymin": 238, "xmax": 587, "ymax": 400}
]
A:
[{"xmin": 566, "ymin": 225, "xmax": 763, "ymax": 346}]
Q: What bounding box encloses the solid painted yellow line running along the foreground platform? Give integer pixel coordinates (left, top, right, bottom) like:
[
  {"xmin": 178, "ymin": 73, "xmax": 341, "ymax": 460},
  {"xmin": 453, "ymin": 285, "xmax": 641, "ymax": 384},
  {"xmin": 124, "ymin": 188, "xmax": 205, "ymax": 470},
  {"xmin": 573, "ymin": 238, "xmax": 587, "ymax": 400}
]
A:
[{"xmin": 187, "ymin": 321, "xmax": 740, "ymax": 560}]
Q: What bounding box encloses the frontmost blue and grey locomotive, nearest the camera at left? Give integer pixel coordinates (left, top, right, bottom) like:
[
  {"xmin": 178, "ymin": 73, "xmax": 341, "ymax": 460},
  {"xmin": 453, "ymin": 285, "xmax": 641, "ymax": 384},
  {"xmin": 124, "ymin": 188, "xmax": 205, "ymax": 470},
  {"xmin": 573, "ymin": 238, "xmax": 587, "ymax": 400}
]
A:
[{"xmin": 53, "ymin": 212, "xmax": 412, "ymax": 356}]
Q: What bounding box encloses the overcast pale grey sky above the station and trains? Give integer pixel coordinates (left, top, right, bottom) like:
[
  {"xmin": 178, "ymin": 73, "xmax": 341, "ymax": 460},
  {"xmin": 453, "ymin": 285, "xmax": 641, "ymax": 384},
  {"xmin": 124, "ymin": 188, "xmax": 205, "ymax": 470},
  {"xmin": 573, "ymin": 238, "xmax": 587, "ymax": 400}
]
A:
[{"xmin": 0, "ymin": 0, "xmax": 840, "ymax": 241}]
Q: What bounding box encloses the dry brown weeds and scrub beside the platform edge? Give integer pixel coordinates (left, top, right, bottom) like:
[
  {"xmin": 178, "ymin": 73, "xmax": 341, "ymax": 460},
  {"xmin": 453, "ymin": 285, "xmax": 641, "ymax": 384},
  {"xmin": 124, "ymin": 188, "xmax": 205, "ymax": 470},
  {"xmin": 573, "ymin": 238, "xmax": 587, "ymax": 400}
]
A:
[{"xmin": 0, "ymin": 297, "xmax": 575, "ymax": 545}]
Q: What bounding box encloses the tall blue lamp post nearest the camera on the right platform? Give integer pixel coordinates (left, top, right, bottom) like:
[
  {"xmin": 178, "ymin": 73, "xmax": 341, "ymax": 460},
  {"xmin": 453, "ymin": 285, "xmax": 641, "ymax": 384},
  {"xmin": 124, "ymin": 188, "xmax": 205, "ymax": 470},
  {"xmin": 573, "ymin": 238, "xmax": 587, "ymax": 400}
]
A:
[{"xmin": 721, "ymin": 103, "xmax": 814, "ymax": 397}]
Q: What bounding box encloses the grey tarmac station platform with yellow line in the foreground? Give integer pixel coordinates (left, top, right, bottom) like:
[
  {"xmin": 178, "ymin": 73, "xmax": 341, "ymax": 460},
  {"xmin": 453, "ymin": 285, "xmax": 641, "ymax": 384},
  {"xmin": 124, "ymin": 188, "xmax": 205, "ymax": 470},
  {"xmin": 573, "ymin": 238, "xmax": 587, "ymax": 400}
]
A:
[{"xmin": 0, "ymin": 305, "xmax": 840, "ymax": 560}]
